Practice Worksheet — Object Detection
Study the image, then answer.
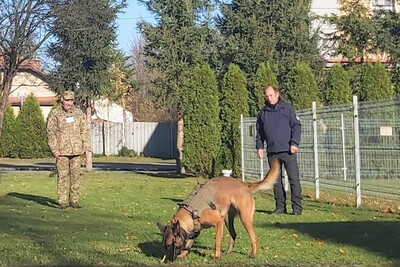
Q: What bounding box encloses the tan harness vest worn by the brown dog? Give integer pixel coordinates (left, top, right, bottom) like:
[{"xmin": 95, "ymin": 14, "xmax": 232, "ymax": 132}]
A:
[{"xmin": 178, "ymin": 184, "xmax": 216, "ymax": 233}]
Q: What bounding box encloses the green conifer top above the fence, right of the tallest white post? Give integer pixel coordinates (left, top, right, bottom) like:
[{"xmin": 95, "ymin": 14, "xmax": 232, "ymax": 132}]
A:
[{"xmin": 359, "ymin": 62, "xmax": 394, "ymax": 101}]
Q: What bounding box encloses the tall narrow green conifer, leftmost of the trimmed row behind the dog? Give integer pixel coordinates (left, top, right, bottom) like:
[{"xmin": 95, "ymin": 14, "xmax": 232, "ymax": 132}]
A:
[{"xmin": 183, "ymin": 65, "xmax": 221, "ymax": 177}]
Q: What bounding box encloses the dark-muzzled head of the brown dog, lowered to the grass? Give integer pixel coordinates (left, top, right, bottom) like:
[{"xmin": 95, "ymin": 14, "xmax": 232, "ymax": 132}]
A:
[{"xmin": 157, "ymin": 221, "xmax": 186, "ymax": 261}]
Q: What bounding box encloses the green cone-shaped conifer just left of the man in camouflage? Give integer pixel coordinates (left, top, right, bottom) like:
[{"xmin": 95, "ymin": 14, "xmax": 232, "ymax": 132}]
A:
[{"xmin": 17, "ymin": 94, "xmax": 51, "ymax": 158}]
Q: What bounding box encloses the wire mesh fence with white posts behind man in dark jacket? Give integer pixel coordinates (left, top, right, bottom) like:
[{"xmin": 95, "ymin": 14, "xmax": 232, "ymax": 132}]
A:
[{"xmin": 241, "ymin": 97, "xmax": 400, "ymax": 206}]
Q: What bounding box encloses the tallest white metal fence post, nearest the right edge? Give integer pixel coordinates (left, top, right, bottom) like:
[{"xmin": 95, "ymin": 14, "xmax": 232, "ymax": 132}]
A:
[{"xmin": 353, "ymin": 95, "xmax": 361, "ymax": 208}]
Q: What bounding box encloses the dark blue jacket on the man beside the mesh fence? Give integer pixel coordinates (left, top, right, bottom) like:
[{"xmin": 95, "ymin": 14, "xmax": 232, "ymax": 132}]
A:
[{"xmin": 256, "ymin": 99, "xmax": 301, "ymax": 153}]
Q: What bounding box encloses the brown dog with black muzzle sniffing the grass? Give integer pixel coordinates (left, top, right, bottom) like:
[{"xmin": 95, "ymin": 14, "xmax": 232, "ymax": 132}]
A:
[{"xmin": 157, "ymin": 161, "xmax": 280, "ymax": 261}]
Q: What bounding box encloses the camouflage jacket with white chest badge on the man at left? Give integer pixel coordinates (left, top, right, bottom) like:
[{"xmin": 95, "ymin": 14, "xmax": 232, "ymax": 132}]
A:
[{"xmin": 47, "ymin": 105, "xmax": 90, "ymax": 156}]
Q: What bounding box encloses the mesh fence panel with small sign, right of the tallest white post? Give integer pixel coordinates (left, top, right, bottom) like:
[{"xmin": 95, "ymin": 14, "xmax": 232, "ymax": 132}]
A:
[{"xmin": 359, "ymin": 99, "xmax": 400, "ymax": 197}]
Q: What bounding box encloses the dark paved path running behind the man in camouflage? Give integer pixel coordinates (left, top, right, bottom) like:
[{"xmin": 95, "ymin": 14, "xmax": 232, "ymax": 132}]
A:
[{"xmin": 0, "ymin": 161, "xmax": 176, "ymax": 173}]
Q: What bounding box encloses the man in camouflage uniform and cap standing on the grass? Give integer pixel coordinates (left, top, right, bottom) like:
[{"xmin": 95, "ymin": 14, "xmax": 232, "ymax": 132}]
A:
[{"xmin": 47, "ymin": 91, "xmax": 90, "ymax": 209}]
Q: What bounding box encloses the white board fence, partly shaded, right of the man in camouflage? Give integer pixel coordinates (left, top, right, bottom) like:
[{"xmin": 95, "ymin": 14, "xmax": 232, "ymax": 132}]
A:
[{"xmin": 91, "ymin": 122, "xmax": 176, "ymax": 159}]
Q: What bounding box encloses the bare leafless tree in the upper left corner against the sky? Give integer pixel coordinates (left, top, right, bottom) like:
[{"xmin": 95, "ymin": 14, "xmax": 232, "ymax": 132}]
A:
[{"xmin": 0, "ymin": 0, "xmax": 55, "ymax": 140}]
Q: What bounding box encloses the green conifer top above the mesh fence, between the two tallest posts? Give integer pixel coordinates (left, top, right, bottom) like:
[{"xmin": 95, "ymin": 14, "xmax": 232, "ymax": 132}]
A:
[{"xmin": 323, "ymin": 63, "xmax": 352, "ymax": 106}]
